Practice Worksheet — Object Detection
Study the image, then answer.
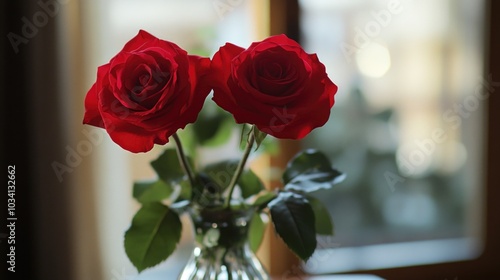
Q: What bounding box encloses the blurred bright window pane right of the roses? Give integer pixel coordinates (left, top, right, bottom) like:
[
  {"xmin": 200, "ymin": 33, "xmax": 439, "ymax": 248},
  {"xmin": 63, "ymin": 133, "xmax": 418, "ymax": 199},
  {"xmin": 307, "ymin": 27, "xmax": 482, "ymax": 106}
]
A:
[{"xmin": 300, "ymin": 0, "xmax": 486, "ymax": 273}]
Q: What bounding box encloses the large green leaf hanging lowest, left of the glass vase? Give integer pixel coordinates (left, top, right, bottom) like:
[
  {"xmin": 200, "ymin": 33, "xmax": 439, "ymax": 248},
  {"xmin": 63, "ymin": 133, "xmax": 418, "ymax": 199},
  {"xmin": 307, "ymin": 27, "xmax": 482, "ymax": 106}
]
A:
[{"xmin": 125, "ymin": 202, "xmax": 182, "ymax": 272}]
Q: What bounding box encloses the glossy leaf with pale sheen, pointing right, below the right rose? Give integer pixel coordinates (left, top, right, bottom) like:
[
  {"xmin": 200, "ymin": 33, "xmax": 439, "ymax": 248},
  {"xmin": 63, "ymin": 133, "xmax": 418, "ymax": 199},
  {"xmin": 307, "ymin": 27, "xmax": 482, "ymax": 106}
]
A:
[{"xmin": 283, "ymin": 150, "xmax": 345, "ymax": 192}]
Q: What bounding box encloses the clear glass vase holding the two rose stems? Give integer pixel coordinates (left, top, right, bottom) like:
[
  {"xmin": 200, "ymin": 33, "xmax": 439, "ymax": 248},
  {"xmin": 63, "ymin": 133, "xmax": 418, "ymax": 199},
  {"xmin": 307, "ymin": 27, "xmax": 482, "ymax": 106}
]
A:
[{"xmin": 178, "ymin": 207, "xmax": 271, "ymax": 280}]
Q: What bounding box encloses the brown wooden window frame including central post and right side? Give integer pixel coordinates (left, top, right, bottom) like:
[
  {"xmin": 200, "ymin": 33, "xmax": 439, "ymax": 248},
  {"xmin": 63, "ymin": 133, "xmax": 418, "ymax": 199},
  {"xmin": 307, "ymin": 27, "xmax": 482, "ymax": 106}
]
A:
[{"xmin": 271, "ymin": 0, "xmax": 500, "ymax": 280}]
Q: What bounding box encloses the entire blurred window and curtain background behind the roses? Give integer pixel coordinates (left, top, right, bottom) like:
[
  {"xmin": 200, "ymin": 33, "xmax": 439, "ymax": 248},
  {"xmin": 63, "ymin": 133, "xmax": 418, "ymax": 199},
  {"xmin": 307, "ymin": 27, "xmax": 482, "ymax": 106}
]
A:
[{"xmin": 0, "ymin": 0, "xmax": 500, "ymax": 280}]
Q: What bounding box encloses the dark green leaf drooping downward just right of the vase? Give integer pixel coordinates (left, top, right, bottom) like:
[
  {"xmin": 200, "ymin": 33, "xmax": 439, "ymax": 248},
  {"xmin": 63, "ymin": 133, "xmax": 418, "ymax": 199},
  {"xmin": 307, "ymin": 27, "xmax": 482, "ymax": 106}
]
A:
[{"xmin": 268, "ymin": 192, "xmax": 316, "ymax": 261}]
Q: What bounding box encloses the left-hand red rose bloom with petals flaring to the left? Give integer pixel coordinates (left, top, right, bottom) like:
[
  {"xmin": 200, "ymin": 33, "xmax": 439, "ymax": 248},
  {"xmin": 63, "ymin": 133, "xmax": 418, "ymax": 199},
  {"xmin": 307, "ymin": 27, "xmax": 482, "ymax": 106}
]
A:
[{"xmin": 83, "ymin": 30, "xmax": 211, "ymax": 153}]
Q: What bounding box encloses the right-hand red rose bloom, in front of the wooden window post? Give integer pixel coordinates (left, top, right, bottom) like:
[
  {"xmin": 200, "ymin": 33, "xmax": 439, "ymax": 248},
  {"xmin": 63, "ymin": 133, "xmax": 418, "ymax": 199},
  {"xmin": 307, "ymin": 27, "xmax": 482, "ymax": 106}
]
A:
[{"xmin": 211, "ymin": 35, "xmax": 337, "ymax": 139}]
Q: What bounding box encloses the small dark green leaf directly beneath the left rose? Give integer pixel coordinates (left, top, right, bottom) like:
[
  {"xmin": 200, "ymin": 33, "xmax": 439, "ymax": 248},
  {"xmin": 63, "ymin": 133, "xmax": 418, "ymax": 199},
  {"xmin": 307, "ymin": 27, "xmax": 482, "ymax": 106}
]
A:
[{"xmin": 151, "ymin": 149, "xmax": 185, "ymax": 183}]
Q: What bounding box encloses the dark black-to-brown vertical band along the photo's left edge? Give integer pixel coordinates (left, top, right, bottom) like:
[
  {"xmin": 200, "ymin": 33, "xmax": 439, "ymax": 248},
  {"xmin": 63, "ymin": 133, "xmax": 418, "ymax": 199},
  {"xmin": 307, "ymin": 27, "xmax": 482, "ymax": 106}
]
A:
[{"xmin": 0, "ymin": 1, "xmax": 73, "ymax": 280}]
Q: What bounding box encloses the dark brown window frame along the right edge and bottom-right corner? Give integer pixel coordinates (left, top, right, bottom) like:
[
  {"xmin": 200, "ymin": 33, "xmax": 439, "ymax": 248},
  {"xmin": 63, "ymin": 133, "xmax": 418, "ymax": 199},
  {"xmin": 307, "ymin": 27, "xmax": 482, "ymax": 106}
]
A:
[{"xmin": 368, "ymin": 0, "xmax": 500, "ymax": 280}]
